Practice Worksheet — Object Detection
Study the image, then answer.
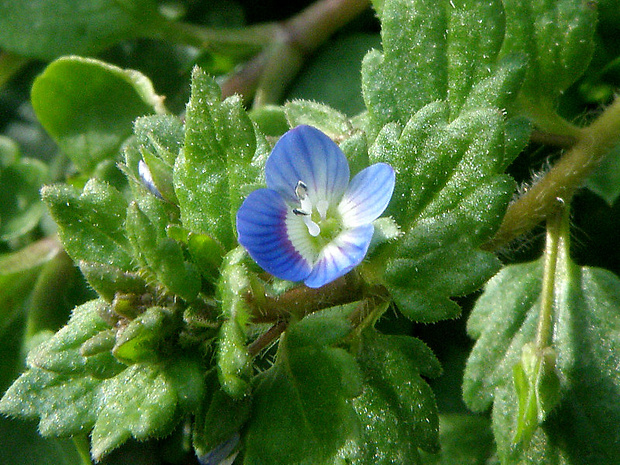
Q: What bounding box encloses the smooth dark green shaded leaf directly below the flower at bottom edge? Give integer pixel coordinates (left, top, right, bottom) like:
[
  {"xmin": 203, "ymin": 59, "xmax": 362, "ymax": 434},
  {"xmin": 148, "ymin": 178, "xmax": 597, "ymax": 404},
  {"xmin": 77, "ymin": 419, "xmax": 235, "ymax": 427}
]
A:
[{"xmin": 245, "ymin": 314, "xmax": 361, "ymax": 464}]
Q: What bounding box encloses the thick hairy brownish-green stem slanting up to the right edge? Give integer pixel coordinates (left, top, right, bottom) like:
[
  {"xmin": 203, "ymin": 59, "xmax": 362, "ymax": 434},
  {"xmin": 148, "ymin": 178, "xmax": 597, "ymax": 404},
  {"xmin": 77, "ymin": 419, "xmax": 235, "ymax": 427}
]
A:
[{"xmin": 483, "ymin": 99, "xmax": 620, "ymax": 250}]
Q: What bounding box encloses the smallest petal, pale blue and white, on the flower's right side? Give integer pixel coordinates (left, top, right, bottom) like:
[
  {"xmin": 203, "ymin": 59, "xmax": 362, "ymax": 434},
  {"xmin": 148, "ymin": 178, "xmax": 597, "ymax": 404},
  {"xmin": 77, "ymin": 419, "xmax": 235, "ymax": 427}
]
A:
[{"xmin": 338, "ymin": 163, "xmax": 396, "ymax": 228}]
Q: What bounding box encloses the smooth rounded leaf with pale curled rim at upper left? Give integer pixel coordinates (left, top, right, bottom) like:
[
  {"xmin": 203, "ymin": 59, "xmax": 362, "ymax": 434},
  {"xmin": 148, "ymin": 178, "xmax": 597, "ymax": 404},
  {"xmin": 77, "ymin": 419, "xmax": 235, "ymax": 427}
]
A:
[{"xmin": 32, "ymin": 57, "xmax": 165, "ymax": 174}]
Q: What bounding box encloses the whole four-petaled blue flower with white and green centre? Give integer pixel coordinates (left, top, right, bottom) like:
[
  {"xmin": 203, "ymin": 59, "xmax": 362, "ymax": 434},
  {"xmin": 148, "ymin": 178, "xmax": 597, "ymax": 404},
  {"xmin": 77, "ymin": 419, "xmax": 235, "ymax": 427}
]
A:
[{"xmin": 237, "ymin": 126, "xmax": 395, "ymax": 288}]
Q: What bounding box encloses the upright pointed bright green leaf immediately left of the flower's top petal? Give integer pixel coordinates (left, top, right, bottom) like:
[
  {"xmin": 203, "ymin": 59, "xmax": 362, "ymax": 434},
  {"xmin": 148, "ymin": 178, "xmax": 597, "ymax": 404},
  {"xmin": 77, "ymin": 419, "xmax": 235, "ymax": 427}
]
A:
[{"xmin": 174, "ymin": 68, "xmax": 268, "ymax": 250}]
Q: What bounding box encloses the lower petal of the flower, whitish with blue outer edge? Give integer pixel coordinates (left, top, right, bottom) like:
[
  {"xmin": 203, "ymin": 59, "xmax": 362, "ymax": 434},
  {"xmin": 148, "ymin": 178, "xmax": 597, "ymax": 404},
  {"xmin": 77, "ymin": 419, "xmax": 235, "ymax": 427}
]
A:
[{"xmin": 304, "ymin": 224, "xmax": 374, "ymax": 288}]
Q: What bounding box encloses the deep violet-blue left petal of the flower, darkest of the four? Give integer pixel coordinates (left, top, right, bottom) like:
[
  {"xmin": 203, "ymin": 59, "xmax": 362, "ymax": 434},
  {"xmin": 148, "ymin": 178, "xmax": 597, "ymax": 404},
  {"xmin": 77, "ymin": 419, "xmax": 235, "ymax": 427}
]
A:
[{"xmin": 237, "ymin": 189, "xmax": 312, "ymax": 281}]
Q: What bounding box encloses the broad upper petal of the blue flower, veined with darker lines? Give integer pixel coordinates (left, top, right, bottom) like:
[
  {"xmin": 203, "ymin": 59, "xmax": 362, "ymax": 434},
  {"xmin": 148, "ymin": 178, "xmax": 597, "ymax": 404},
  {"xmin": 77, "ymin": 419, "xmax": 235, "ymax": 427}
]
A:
[{"xmin": 265, "ymin": 126, "xmax": 349, "ymax": 204}]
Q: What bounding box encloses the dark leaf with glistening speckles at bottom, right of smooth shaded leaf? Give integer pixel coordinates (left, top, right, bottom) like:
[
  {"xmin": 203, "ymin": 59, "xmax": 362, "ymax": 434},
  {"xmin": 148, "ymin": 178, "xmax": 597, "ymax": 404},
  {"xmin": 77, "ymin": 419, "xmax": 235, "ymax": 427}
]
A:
[{"xmin": 344, "ymin": 331, "xmax": 441, "ymax": 464}]
